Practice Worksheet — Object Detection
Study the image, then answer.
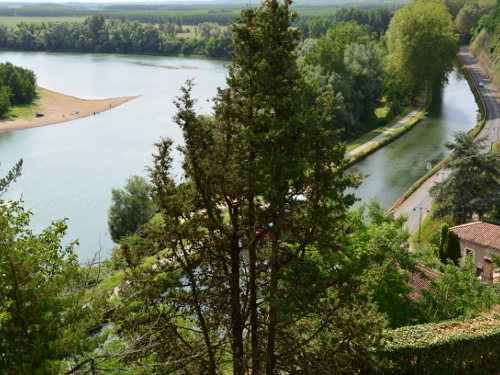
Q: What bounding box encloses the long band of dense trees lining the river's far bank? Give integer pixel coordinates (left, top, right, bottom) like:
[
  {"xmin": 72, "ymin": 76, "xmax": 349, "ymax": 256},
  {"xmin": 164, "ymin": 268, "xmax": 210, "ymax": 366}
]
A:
[{"xmin": 0, "ymin": 15, "xmax": 230, "ymax": 58}]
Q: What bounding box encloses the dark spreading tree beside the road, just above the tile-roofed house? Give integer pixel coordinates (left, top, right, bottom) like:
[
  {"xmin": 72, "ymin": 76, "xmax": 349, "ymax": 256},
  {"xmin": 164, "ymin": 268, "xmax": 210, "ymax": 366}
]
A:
[{"xmin": 429, "ymin": 132, "xmax": 500, "ymax": 224}]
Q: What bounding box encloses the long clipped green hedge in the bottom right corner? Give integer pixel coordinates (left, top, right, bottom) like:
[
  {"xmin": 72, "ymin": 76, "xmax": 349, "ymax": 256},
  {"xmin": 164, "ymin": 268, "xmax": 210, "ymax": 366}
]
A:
[{"xmin": 363, "ymin": 314, "xmax": 500, "ymax": 375}]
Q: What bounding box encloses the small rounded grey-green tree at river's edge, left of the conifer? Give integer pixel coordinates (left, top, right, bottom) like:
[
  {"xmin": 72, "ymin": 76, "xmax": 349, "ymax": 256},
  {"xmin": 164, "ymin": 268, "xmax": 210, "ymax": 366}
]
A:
[{"xmin": 108, "ymin": 176, "xmax": 153, "ymax": 242}]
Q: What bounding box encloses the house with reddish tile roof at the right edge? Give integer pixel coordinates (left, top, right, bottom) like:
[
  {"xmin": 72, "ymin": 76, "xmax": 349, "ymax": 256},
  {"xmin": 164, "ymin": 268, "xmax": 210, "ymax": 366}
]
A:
[{"xmin": 450, "ymin": 221, "xmax": 500, "ymax": 281}]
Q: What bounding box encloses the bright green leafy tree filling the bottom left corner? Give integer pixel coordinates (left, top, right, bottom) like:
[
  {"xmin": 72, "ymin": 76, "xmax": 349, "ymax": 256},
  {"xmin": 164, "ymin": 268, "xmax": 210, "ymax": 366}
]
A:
[{"xmin": 0, "ymin": 202, "xmax": 105, "ymax": 375}]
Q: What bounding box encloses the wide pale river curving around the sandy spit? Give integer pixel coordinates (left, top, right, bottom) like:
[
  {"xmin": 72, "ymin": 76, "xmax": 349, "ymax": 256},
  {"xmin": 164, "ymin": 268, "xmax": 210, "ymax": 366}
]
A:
[{"xmin": 0, "ymin": 52, "xmax": 226, "ymax": 260}]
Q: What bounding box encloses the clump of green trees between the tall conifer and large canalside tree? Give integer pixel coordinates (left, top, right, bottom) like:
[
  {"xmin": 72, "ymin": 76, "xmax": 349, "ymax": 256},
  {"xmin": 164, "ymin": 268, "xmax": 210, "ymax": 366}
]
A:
[{"xmin": 299, "ymin": 21, "xmax": 384, "ymax": 133}]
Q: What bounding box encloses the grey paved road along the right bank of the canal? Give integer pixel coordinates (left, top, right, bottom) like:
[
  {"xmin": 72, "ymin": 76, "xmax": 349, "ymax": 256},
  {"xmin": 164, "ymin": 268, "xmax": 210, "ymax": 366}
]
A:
[{"xmin": 396, "ymin": 47, "xmax": 500, "ymax": 233}]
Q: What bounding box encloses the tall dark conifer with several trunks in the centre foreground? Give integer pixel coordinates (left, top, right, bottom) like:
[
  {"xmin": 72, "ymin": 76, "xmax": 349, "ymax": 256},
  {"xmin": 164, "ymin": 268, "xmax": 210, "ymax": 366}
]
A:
[{"xmin": 111, "ymin": 0, "xmax": 392, "ymax": 375}]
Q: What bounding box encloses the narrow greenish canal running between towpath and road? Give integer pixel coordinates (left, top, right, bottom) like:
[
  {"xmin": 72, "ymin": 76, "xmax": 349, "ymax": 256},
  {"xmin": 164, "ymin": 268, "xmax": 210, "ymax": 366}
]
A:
[{"xmin": 348, "ymin": 64, "xmax": 479, "ymax": 212}]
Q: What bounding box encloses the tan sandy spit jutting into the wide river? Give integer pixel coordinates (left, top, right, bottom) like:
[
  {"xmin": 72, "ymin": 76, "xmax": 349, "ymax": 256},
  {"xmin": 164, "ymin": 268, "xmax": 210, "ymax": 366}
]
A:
[{"xmin": 0, "ymin": 87, "xmax": 137, "ymax": 133}]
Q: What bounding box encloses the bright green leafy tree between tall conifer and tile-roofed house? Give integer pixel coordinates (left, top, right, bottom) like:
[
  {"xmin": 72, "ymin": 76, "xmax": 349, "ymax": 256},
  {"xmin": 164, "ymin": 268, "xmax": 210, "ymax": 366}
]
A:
[{"xmin": 348, "ymin": 201, "xmax": 421, "ymax": 328}]
